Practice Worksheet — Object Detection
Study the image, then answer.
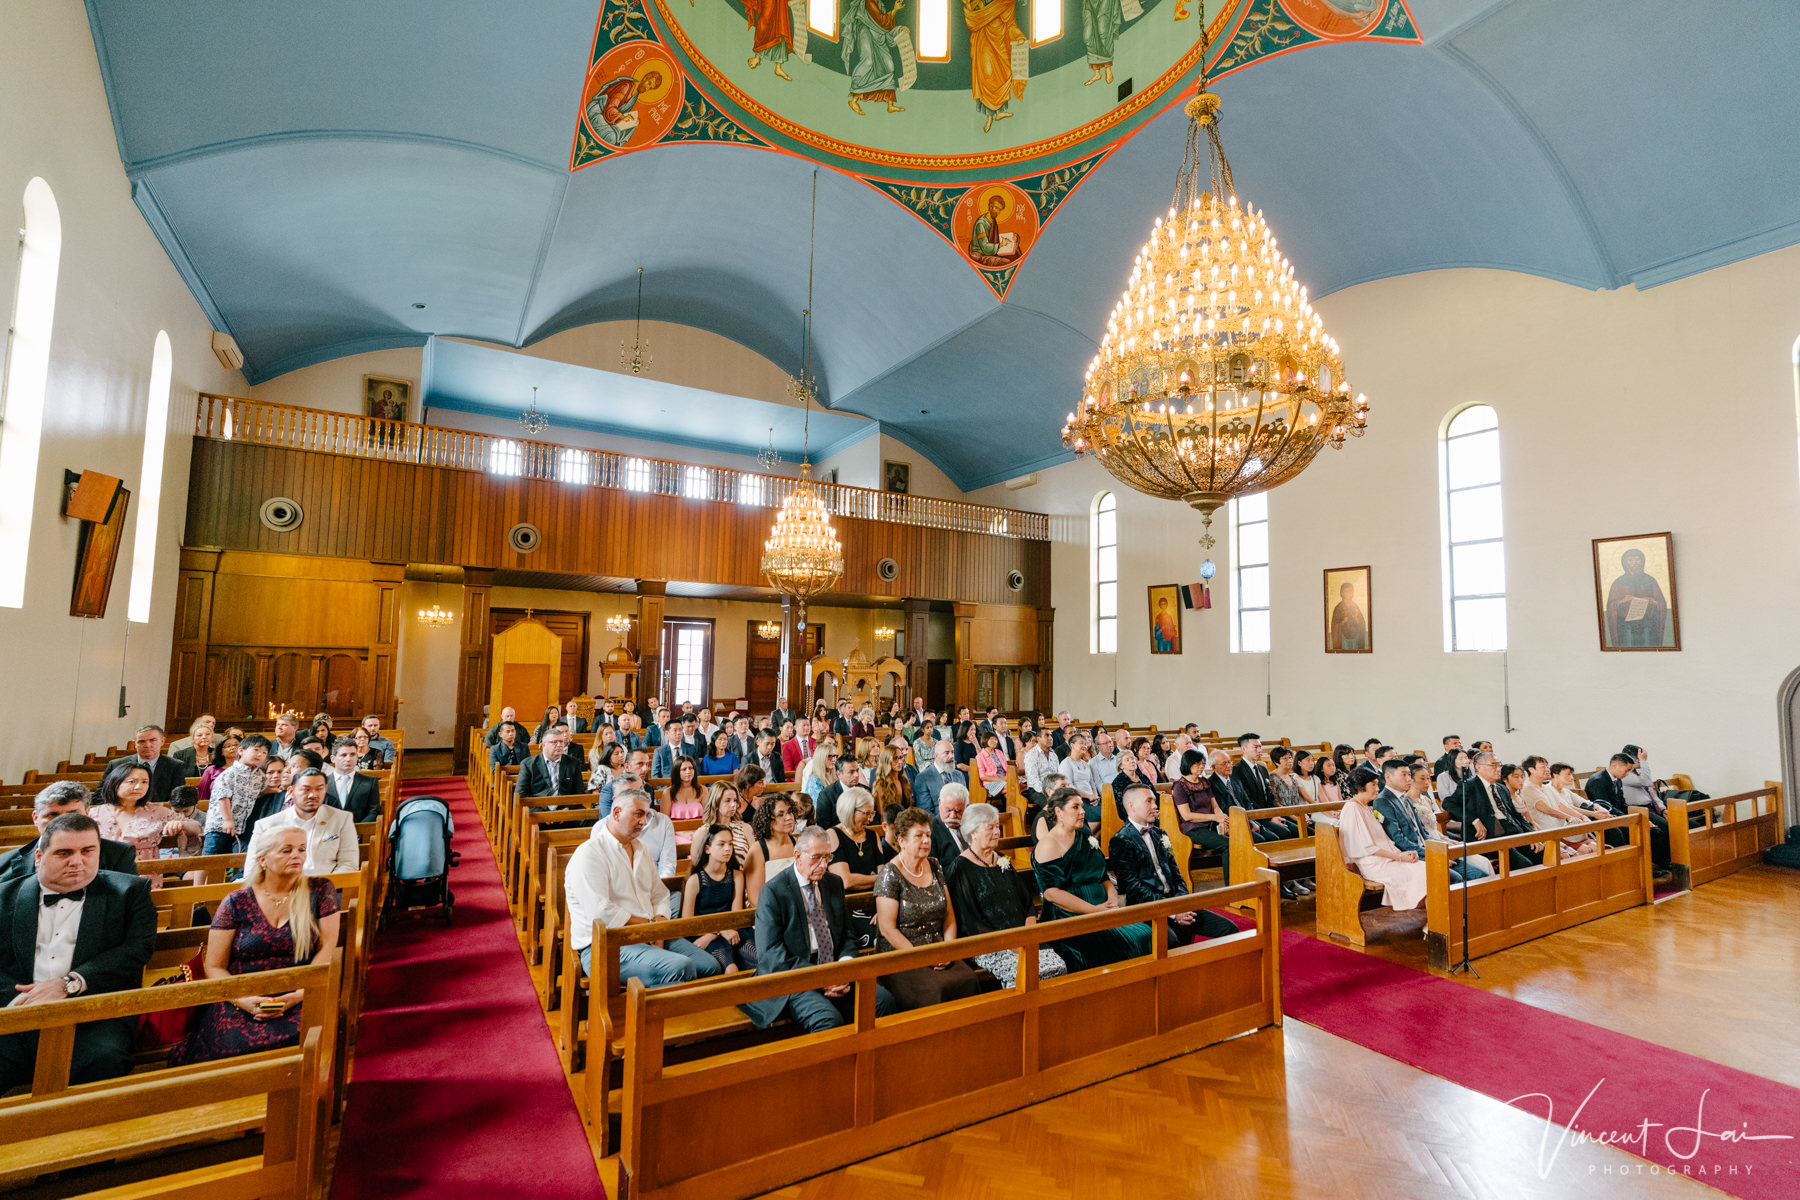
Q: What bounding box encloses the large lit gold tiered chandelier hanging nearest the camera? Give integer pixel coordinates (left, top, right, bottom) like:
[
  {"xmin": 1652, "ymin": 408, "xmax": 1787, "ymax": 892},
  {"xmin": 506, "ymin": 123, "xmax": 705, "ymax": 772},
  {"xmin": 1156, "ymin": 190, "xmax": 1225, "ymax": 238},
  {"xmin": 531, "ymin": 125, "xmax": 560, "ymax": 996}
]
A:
[{"xmin": 1062, "ymin": 79, "xmax": 1368, "ymax": 549}]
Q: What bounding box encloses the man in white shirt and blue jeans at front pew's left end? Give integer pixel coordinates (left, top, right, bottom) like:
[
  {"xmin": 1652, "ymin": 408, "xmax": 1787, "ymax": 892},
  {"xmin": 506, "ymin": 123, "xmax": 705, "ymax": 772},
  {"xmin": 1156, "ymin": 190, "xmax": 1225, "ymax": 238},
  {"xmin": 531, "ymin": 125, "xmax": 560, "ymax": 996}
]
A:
[{"xmin": 563, "ymin": 792, "xmax": 718, "ymax": 988}]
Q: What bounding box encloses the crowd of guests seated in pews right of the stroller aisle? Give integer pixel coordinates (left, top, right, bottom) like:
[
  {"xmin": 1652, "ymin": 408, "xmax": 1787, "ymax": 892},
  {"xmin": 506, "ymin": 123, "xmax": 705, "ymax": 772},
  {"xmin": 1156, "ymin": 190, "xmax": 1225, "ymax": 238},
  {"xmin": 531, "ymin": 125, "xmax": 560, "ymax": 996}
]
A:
[{"xmin": 525, "ymin": 702, "xmax": 1669, "ymax": 1029}]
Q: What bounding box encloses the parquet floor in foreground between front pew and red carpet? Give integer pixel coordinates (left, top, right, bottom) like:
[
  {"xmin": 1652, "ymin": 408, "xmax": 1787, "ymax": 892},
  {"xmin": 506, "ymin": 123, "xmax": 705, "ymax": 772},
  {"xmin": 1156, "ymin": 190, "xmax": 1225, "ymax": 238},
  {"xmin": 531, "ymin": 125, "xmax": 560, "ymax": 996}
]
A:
[{"xmin": 752, "ymin": 1020, "xmax": 1717, "ymax": 1200}]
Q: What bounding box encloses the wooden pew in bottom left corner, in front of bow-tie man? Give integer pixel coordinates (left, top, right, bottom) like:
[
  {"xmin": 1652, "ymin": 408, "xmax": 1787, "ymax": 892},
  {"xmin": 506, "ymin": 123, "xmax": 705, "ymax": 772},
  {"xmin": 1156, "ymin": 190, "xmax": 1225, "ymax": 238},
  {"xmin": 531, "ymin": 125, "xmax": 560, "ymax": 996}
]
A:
[{"xmin": 0, "ymin": 963, "xmax": 338, "ymax": 1200}]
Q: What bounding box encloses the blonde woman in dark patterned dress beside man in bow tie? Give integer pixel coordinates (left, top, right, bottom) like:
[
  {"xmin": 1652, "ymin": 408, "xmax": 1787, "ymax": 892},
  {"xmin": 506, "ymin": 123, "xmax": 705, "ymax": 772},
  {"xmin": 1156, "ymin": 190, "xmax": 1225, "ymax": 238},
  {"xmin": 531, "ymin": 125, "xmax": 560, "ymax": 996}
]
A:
[{"xmin": 175, "ymin": 824, "xmax": 338, "ymax": 1063}]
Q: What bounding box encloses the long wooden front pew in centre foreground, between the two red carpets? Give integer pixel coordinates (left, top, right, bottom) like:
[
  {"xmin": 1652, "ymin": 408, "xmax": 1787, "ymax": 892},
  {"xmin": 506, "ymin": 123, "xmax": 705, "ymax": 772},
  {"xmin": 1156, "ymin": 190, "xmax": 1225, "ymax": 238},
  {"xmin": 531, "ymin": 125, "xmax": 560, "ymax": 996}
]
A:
[{"xmin": 619, "ymin": 873, "xmax": 1282, "ymax": 1200}]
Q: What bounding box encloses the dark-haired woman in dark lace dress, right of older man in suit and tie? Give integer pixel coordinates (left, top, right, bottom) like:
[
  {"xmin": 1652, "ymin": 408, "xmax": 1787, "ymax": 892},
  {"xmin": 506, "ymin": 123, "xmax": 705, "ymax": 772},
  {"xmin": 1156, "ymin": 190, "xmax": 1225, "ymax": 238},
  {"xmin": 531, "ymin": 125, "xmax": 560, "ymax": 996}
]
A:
[{"xmin": 875, "ymin": 808, "xmax": 981, "ymax": 1011}]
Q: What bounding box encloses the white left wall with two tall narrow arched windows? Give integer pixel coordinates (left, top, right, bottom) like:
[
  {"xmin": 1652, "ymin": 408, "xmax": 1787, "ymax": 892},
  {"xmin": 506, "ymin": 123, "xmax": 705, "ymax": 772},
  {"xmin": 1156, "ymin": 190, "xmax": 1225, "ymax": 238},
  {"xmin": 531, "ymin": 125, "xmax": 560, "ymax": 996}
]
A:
[{"xmin": 0, "ymin": 0, "xmax": 245, "ymax": 779}]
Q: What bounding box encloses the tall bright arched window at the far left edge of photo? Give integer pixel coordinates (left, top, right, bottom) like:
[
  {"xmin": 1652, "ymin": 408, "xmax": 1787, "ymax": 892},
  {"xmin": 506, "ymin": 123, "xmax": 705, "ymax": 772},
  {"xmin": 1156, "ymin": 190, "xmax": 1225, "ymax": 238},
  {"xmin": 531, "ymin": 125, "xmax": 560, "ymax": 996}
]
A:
[{"xmin": 0, "ymin": 178, "xmax": 63, "ymax": 608}]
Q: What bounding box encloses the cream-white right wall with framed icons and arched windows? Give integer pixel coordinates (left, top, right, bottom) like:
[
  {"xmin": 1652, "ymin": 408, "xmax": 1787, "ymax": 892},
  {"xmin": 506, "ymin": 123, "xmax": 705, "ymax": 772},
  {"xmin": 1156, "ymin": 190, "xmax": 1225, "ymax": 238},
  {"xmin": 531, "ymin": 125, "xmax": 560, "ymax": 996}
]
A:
[{"xmin": 970, "ymin": 259, "xmax": 1800, "ymax": 793}]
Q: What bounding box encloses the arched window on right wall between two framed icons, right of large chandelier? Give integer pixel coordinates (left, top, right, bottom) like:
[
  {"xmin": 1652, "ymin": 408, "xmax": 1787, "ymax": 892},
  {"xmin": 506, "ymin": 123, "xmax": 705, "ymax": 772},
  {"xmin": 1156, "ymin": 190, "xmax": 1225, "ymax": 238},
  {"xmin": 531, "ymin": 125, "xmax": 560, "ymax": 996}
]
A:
[{"xmin": 1440, "ymin": 405, "xmax": 1507, "ymax": 649}]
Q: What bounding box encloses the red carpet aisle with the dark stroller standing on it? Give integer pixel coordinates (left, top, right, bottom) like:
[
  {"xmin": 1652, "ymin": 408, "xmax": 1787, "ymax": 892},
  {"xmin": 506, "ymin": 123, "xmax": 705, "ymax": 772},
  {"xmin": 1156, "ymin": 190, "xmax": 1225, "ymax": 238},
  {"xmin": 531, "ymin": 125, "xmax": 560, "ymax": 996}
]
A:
[{"xmin": 333, "ymin": 779, "xmax": 607, "ymax": 1200}]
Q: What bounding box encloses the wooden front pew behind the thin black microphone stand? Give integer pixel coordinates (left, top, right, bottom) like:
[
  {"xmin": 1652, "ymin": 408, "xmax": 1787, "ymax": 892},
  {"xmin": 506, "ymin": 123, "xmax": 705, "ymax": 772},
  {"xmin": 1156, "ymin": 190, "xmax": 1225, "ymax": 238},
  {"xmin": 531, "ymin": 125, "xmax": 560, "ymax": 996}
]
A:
[{"xmin": 1426, "ymin": 810, "xmax": 1652, "ymax": 970}]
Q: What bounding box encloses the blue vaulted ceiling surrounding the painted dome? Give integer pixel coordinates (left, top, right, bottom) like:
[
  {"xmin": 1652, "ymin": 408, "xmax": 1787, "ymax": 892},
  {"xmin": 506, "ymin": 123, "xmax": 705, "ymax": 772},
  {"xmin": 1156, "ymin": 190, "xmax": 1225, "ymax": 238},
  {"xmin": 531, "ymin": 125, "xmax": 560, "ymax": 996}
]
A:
[{"xmin": 88, "ymin": 0, "xmax": 1800, "ymax": 488}]
